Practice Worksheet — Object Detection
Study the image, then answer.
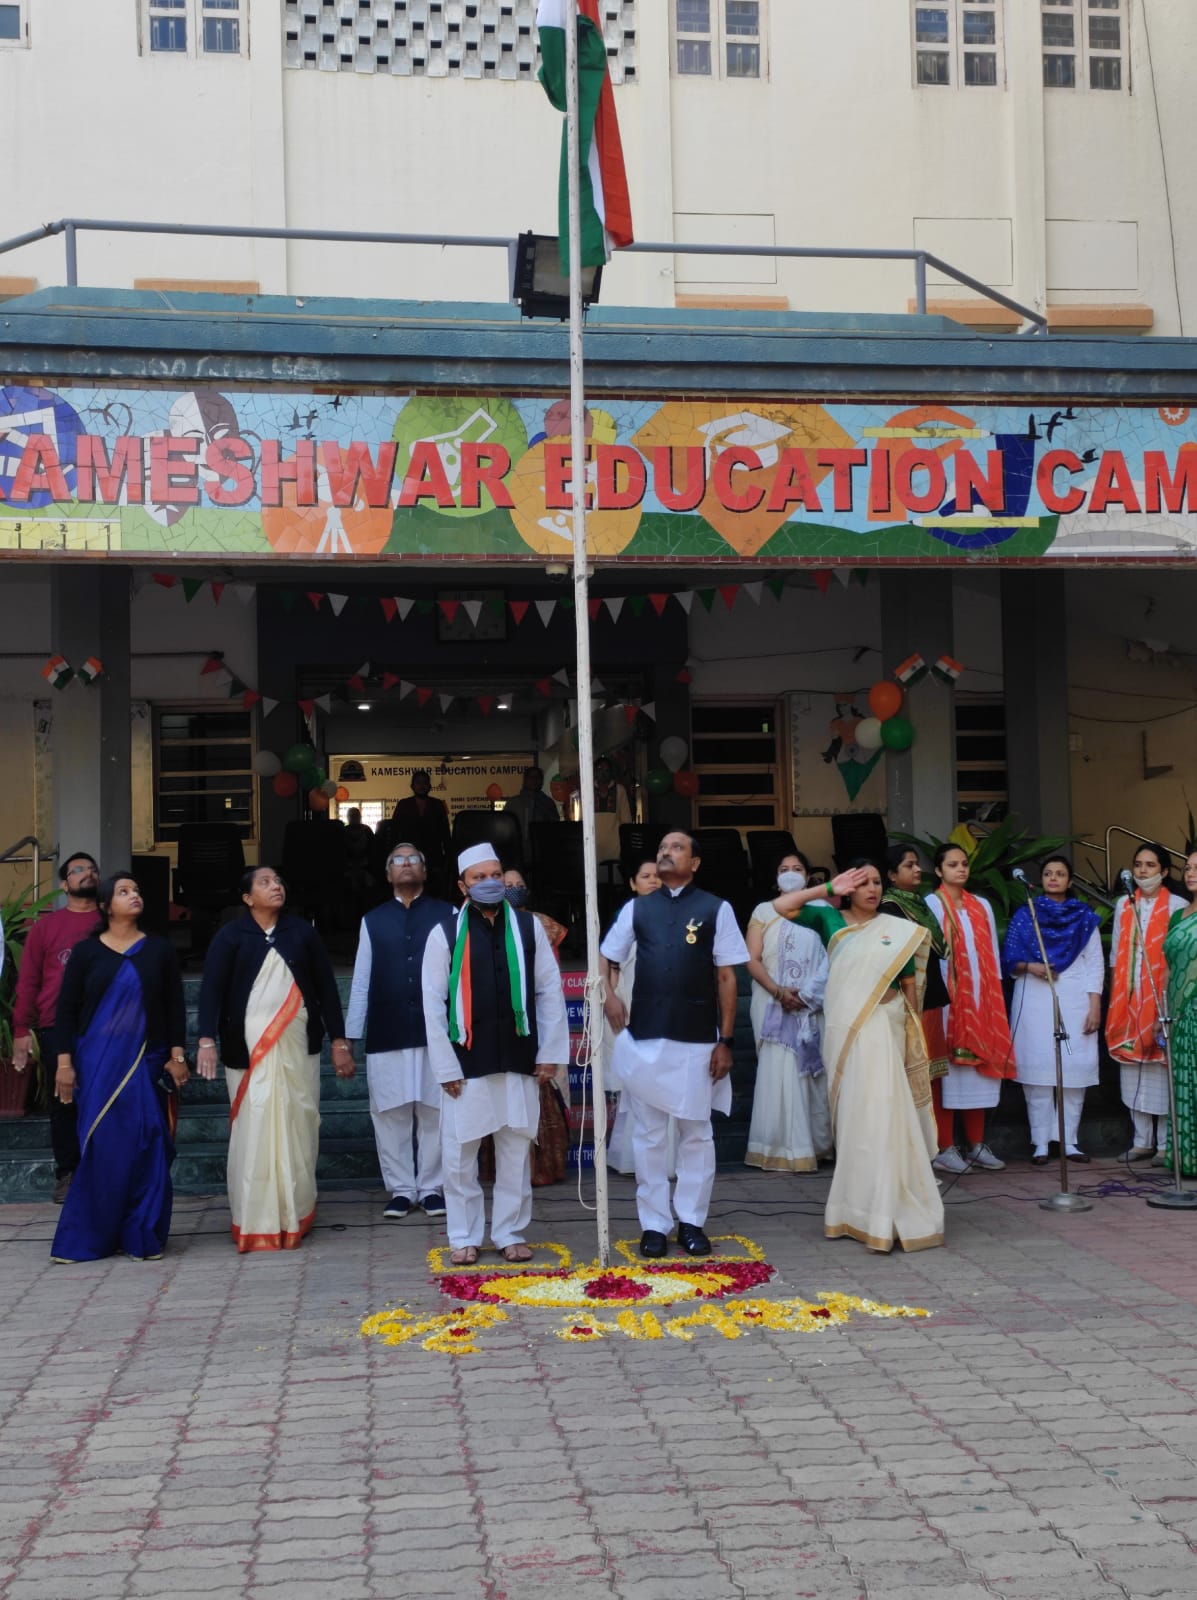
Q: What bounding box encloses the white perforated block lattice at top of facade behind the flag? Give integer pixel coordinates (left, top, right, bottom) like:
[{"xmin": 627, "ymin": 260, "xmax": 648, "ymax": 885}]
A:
[{"xmin": 283, "ymin": 0, "xmax": 636, "ymax": 83}]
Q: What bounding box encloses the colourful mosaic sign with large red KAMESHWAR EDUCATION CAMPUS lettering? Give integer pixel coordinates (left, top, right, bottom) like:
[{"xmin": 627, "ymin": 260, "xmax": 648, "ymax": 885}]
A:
[{"xmin": 0, "ymin": 386, "xmax": 1197, "ymax": 566}]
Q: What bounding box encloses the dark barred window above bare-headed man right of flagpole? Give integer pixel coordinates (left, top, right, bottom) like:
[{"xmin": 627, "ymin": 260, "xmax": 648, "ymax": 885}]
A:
[{"xmin": 690, "ymin": 699, "xmax": 783, "ymax": 827}]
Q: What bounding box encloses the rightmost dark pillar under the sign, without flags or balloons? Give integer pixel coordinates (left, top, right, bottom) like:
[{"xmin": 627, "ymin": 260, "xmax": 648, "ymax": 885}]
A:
[{"xmin": 1002, "ymin": 571, "xmax": 1072, "ymax": 834}]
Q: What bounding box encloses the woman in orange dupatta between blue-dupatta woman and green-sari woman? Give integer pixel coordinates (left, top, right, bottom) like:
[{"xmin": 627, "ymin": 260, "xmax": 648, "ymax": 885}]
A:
[{"xmin": 1106, "ymin": 845, "xmax": 1184, "ymax": 1166}]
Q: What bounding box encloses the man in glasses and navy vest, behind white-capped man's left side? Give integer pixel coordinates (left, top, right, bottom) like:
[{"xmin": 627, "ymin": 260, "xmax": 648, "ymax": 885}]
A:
[{"xmin": 346, "ymin": 843, "xmax": 453, "ymax": 1221}]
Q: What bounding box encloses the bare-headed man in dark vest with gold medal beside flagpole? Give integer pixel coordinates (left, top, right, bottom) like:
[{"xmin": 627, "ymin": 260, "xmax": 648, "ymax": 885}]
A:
[{"xmin": 602, "ymin": 834, "xmax": 749, "ymax": 1258}]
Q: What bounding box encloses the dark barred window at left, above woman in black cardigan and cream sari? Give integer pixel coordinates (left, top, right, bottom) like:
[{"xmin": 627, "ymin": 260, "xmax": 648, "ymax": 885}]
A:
[{"xmin": 154, "ymin": 706, "xmax": 256, "ymax": 843}]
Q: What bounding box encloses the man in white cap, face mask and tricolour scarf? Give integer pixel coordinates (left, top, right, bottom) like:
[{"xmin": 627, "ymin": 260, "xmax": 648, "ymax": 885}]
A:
[{"xmin": 422, "ymin": 845, "xmax": 570, "ymax": 1267}]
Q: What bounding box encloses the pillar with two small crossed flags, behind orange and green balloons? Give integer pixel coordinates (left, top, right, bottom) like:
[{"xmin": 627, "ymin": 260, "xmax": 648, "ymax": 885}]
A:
[{"xmin": 877, "ymin": 571, "xmax": 955, "ymax": 838}]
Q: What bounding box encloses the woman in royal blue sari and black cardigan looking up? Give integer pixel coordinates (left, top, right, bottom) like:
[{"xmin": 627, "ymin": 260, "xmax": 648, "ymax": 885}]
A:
[{"xmin": 50, "ymin": 872, "xmax": 187, "ymax": 1261}]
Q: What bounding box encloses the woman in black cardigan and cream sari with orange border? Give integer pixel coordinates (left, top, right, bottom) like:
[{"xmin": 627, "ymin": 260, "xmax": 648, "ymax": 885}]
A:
[{"xmin": 197, "ymin": 867, "xmax": 354, "ymax": 1251}]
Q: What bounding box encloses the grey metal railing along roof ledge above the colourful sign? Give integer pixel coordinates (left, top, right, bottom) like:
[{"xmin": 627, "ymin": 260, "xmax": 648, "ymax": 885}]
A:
[{"xmin": 0, "ymin": 216, "xmax": 1048, "ymax": 334}]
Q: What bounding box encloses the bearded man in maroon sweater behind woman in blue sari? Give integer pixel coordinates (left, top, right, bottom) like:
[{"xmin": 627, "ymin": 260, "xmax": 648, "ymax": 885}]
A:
[{"xmin": 13, "ymin": 850, "xmax": 99, "ymax": 1205}]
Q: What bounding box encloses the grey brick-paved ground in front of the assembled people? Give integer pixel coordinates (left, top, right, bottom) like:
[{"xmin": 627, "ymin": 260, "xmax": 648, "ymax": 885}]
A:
[{"xmin": 0, "ymin": 1166, "xmax": 1197, "ymax": 1600}]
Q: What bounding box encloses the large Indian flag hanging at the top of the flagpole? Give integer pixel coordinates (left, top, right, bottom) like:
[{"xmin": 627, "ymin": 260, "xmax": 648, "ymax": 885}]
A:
[{"xmin": 536, "ymin": 0, "xmax": 632, "ymax": 274}]
